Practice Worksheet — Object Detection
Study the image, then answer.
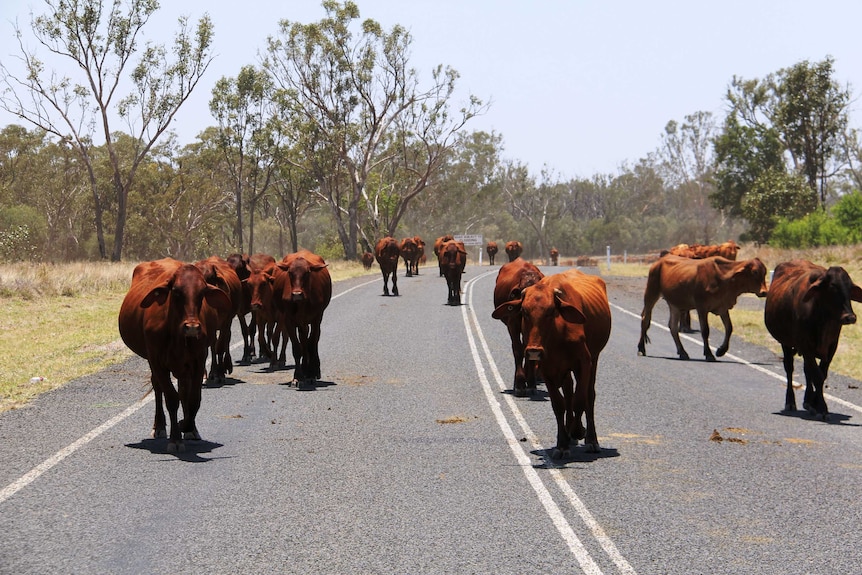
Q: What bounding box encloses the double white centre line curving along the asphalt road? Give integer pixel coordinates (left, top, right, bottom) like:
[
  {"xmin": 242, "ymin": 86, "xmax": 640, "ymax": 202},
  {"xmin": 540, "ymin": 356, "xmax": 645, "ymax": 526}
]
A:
[{"xmin": 462, "ymin": 270, "xmax": 635, "ymax": 575}]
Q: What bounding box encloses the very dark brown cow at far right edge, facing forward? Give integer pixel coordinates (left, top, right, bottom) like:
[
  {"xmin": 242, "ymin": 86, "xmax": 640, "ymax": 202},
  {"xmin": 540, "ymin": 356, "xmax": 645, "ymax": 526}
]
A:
[{"xmin": 763, "ymin": 260, "xmax": 862, "ymax": 421}]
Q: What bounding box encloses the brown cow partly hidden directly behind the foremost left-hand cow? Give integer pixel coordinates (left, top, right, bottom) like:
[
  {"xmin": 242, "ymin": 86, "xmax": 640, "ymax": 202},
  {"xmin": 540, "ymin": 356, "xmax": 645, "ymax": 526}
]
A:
[{"xmin": 195, "ymin": 256, "xmax": 245, "ymax": 382}]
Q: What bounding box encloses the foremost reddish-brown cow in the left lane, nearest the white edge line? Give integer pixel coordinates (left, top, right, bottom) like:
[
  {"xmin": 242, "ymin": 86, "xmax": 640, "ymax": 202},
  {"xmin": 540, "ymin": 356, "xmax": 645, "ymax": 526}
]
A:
[{"xmin": 118, "ymin": 258, "xmax": 233, "ymax": 452}]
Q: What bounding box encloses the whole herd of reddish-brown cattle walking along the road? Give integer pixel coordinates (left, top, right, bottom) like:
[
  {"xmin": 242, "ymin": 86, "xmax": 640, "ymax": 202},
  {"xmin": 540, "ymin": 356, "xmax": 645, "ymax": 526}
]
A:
[{"xmin": 118, "ymin": 235, "xmax": 862, "ymax": 459}]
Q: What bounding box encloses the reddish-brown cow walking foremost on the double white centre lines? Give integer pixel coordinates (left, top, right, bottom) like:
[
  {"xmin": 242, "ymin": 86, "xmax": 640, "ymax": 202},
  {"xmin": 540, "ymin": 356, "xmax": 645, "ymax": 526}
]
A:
[{"xmin": 492, "ymin": 269, "xmax": 611, "ymax": 459}]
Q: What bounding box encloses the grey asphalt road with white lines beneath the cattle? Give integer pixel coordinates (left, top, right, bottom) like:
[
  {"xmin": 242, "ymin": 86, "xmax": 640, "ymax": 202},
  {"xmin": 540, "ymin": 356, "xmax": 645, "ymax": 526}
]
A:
[{"xmin": 0, "ymin": 266, "xmax": 862, "ymax": 575}]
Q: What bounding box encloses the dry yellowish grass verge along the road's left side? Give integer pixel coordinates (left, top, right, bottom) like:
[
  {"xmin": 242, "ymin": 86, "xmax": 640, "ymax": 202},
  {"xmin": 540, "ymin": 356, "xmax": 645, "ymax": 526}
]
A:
[{"xmin": 0, "ymin": 261, "xmax": 373, "ymax": 412}]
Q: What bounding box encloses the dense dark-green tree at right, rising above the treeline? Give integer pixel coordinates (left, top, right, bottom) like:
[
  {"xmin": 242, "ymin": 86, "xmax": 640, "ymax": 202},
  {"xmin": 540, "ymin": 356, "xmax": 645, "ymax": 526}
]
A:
[{"xmin": 712, "ymin": 57, "xmax": 850, "ymax": 230}]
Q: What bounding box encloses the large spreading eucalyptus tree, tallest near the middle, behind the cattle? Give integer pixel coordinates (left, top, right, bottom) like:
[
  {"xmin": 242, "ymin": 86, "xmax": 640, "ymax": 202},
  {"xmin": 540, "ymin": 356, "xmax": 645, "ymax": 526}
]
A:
[{"xmin": 264, "ymin": 0, "xmax": 484, "ymax": 259}]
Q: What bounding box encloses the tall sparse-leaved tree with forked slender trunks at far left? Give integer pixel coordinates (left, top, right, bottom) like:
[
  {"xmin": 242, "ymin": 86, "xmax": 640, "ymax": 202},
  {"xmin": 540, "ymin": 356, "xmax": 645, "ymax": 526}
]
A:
[{"xmin": 0, "ymin": 0, "xmax": 212, "ymax": 261}]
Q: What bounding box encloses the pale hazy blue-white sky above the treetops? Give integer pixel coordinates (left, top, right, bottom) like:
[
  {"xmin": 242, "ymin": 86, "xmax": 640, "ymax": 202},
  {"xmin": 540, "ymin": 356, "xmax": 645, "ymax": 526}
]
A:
[{"xmin": 0, "ymin": 0, "xmax": 862, "ymax": 178}]
